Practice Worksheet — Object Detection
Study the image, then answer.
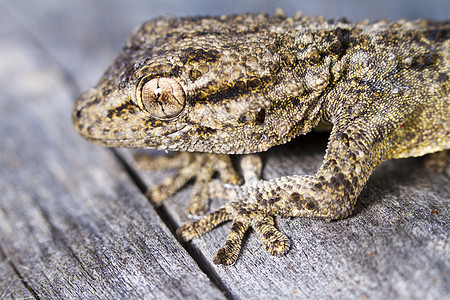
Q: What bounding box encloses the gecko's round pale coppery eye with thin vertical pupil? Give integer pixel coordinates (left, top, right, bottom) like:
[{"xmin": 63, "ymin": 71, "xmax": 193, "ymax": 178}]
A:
[{"xmin": 141, "ymin": 77, "xmax": 186, "ymax": 119}]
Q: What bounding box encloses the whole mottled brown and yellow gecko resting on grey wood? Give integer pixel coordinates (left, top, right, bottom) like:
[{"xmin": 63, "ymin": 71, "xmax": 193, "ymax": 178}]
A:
[{"xmin": 72, "ymin": 11, "xmax": 450, "ymax": 265}]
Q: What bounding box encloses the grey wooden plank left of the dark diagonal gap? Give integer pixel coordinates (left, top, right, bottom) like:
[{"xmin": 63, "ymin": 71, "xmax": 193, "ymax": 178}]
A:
[{"xmin": 0, "ymin": 4, "xmax": 224, "ymax": 299}]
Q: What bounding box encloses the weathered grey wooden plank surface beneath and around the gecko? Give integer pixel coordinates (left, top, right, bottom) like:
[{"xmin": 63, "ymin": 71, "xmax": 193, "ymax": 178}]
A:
[{"xmin": 0, "ymin": 0, "xmax": 450, "ymax": 299}]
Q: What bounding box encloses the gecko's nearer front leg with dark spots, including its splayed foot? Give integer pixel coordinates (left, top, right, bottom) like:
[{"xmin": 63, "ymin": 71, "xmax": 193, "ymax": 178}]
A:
[{"xmin": 178, "ymin": 122, "xmax": 382, "ymax": 265}]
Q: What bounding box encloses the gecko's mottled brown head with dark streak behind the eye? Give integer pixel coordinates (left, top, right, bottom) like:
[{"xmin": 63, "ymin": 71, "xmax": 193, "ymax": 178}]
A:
[{"xmin": 73, "ymin": 15, "xmax": 334, "ymax": 153}]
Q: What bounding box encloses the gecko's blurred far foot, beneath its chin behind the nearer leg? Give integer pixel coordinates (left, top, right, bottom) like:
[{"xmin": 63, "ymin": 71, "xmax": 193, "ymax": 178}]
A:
[{"xmin": 134, "ymin": 152, "xmax": 242, "ymax": 215}]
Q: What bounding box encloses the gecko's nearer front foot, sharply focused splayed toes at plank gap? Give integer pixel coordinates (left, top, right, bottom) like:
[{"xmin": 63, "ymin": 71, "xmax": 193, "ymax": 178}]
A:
[{"xmin": 177, "ymin": 202, "xmax": 290, "ymax": 266}]
